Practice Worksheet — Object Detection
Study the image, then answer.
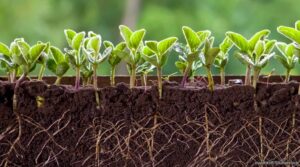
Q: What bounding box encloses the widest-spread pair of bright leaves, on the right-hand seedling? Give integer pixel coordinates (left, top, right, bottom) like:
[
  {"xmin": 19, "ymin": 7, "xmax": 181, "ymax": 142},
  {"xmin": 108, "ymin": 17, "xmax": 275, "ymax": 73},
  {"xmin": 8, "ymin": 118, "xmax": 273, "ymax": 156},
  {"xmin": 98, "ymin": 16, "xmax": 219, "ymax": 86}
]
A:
[{"xmin": 226, "ymin": 29, "xmax": 270, "ymax": 53}]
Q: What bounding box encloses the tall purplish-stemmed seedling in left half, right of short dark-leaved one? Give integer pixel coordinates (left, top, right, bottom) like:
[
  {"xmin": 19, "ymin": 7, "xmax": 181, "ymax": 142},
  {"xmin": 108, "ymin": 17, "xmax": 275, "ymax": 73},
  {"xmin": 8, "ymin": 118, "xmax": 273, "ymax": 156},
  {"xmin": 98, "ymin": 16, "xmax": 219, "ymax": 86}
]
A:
[{"xmin": 64, "ymin": 29, "xmax": 86, "ymax": 89}]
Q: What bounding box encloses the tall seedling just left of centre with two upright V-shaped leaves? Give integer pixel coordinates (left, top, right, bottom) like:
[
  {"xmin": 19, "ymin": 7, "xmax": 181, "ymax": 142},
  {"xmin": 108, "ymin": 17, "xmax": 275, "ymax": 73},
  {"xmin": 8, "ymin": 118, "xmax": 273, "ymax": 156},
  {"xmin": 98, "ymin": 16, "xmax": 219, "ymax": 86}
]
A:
[{"xmin": 119, "ymin": 25, "xmax": 146, "ymax": 88}]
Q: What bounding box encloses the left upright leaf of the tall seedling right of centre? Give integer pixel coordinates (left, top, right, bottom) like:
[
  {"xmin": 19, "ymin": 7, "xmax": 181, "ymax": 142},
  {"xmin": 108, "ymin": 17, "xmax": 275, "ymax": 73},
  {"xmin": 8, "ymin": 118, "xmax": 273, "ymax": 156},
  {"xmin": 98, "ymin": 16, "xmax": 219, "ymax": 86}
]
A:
[{"xmin": 182, "ymin": 26, "xmax": 201, "ymax": 52}]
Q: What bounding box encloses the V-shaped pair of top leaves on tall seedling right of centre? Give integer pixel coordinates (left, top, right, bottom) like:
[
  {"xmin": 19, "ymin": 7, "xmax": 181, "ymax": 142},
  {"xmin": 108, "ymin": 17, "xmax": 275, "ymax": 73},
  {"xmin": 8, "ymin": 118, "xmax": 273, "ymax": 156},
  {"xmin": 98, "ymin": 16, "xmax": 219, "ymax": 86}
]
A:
[{"xmin": 182, "ymin": 26, "xmax": 211, "ymax": 52}]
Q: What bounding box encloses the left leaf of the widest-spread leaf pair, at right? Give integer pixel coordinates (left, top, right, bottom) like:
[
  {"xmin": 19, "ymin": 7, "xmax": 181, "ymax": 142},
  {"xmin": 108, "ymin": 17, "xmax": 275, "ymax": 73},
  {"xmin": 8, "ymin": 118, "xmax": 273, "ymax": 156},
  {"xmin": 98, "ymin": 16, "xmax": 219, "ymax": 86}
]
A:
[{"xmin": 226, "ymin": 32, "xmax": 249, "ymax": 52}]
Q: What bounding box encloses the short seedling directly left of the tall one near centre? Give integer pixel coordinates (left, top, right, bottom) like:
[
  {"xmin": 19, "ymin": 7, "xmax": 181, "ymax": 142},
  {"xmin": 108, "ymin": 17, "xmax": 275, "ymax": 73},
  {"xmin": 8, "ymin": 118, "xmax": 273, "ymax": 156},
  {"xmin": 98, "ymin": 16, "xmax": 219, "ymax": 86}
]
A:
[{"xmin": 103, "ymin": 41, "xmax": 126, "ymax": 86}]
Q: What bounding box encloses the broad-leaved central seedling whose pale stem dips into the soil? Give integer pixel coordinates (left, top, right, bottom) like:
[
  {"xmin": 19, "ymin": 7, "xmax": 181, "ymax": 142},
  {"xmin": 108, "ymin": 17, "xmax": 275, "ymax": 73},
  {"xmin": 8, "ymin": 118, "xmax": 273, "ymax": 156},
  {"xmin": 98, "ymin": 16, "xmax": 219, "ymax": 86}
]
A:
[{"xmin": 142, "ymin": 37, "xmax": 177, "ymax": 98}]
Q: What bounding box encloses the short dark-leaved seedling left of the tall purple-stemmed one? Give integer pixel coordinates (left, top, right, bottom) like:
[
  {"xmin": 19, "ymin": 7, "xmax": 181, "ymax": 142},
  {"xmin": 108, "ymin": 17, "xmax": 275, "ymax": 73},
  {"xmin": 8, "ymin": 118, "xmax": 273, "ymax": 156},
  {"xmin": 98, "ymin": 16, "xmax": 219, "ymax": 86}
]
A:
[{"xmin": 46, "ymin": 46, "xmax": 70, "ymax": 85}]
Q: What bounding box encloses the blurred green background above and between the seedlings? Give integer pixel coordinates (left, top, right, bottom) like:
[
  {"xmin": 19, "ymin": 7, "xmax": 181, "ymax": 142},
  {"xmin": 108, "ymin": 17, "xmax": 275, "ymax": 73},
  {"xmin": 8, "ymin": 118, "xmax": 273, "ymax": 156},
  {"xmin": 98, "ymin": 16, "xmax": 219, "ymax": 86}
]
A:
[{"xmin": 0, "ymin": 0, "xmax": 300, "ymax": 75}]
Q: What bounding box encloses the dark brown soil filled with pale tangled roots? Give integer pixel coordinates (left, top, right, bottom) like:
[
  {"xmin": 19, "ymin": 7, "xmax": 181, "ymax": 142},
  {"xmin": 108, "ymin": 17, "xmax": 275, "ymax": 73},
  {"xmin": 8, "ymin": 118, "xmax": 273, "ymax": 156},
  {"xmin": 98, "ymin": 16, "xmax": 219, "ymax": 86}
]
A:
[{"xmin": 0, "ymin": 79, "xmax": 300, "ymax": 167}]
